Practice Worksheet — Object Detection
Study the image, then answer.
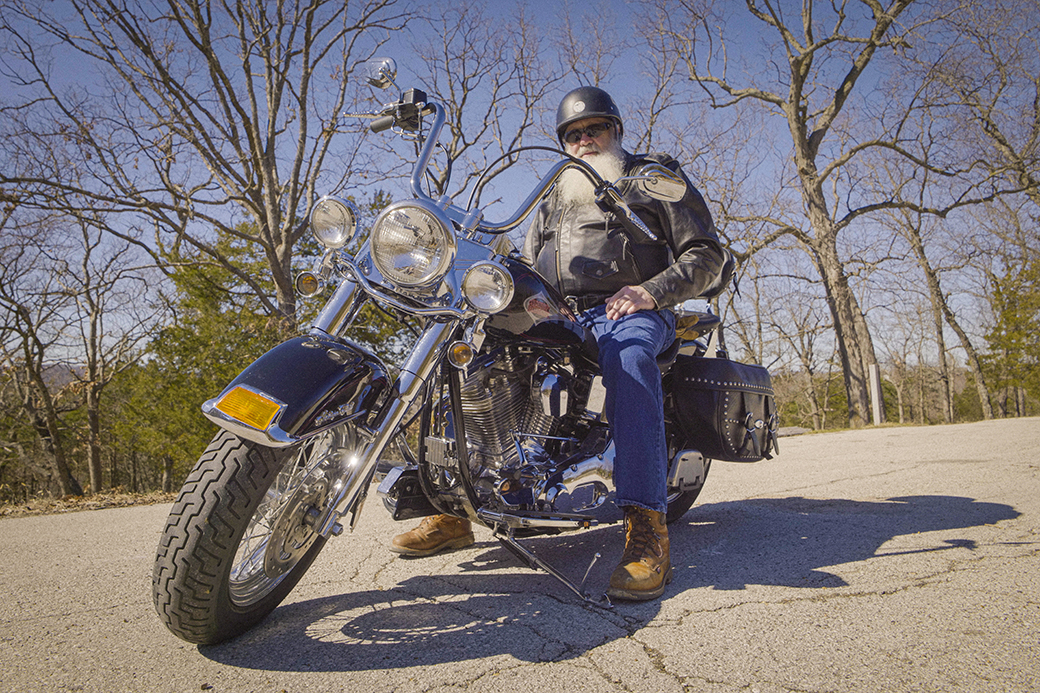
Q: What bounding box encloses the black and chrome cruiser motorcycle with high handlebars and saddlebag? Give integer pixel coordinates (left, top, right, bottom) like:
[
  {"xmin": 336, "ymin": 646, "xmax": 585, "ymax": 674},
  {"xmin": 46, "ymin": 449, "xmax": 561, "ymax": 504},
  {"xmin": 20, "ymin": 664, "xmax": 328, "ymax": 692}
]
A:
[{"xmin": 152, "ymin": 59, "xmax": 776, "ymax": 644}]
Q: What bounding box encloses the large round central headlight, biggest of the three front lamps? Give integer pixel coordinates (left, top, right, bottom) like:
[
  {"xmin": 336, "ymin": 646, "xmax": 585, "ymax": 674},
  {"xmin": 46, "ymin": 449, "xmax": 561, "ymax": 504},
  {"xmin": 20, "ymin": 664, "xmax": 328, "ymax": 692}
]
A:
[{"xmin": 369, "ymin": 201, "xmax": 457, "ymax": 288}]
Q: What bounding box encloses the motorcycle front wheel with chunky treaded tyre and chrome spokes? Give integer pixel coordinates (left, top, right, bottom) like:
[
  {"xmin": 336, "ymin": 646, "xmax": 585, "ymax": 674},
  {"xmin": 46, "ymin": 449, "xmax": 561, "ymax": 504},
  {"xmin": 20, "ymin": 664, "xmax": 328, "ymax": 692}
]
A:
[{"xmin": 146, "ymin": 427, "xmax": 356, "ymax": 644}]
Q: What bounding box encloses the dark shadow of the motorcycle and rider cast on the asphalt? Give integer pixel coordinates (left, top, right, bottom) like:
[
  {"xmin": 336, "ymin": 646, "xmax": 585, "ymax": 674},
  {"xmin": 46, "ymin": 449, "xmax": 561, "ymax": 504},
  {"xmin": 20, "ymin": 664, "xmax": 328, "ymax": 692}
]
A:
[{"xmin": 199, "ymin": 495, "xmax": 1019, "ymax": 671}]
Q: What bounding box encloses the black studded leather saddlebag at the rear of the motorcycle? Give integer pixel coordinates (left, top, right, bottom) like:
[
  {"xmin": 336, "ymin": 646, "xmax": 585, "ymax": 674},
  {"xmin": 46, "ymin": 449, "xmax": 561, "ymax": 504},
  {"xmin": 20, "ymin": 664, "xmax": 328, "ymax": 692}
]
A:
[{"xmin": 670, "ymin": 355, "xmax": 779, "ymax": 462}]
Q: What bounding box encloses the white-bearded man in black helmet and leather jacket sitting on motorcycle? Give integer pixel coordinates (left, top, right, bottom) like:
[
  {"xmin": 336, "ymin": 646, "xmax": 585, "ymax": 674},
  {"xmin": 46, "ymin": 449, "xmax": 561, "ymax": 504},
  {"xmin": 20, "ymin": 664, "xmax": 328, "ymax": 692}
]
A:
[{"xmin": 393, "ymin": 86, "xmax": 724, "ymax": 600}]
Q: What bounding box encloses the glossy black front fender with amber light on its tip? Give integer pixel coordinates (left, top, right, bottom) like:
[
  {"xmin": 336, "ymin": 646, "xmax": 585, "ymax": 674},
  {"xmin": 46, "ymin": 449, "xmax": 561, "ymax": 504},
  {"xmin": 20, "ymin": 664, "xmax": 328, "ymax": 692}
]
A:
[{"xmin": 202, "ymin": 333, "xmax": 389, "ymax": 447}]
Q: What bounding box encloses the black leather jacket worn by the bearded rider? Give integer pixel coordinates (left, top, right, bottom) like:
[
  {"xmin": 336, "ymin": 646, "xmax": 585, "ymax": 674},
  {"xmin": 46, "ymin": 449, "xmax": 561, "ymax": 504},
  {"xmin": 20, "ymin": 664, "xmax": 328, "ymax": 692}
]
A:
[{"xmin": 523, "ymin": 152, "xmax": 724, "ymax": 308}]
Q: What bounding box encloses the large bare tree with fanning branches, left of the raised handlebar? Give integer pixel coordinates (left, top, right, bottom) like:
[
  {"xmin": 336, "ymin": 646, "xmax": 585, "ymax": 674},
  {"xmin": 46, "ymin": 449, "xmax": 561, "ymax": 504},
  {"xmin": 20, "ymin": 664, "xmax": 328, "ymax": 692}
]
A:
[{"xmin": 0, "ymin": 0, "xmax": 408, "ymax": 326}]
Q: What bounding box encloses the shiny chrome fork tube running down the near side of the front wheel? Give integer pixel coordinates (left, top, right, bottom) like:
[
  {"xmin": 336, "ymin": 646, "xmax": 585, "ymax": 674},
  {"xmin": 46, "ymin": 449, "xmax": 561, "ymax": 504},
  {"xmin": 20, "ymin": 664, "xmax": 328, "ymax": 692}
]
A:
[{"xmin": 319, "ymin": 320, "xmax": 457, "ymax": 537}]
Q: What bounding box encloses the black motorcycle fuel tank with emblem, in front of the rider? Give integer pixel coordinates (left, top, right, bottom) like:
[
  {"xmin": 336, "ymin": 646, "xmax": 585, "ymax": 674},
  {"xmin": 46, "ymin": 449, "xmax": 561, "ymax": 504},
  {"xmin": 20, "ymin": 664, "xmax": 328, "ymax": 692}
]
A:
[{"xmin": 484, "ymin": 258, "xmax": 592, "ymax": 347}]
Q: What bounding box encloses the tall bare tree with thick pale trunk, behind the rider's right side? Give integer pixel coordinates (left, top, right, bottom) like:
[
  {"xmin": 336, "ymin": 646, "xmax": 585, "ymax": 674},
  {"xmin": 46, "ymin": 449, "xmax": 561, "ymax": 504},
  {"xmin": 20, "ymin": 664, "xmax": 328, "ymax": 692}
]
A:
[{"xmin": 632, "ymin": 0, "xmax": 1023, "ymax": 426}]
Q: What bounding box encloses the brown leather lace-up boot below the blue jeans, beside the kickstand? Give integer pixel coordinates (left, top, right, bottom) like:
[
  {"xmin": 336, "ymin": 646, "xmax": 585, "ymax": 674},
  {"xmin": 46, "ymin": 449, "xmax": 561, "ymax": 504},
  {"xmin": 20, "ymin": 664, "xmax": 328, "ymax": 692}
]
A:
[{"xmin": 606, "ymin": 506, "xmax": 672, "ymax": 601}]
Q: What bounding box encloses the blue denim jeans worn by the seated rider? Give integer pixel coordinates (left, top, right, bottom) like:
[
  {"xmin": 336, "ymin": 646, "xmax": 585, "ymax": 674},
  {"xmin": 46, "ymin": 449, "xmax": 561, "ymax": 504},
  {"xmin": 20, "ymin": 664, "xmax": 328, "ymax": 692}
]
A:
[{"xmin": 579, "ymin": 306, "xmax": 675, "ymax": 512}]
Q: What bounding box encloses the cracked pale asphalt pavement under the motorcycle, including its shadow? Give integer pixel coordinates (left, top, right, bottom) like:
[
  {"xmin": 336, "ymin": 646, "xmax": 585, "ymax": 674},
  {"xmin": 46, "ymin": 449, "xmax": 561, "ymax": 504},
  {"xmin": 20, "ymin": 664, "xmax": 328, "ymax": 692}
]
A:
[{"xmin": 0, "ymin": 418, "xmax": 1040, "ymax": 693}]
